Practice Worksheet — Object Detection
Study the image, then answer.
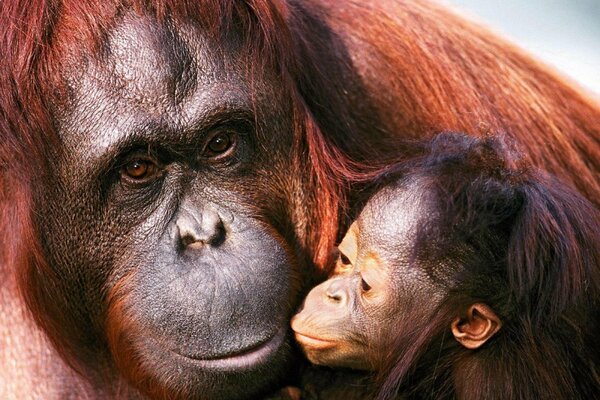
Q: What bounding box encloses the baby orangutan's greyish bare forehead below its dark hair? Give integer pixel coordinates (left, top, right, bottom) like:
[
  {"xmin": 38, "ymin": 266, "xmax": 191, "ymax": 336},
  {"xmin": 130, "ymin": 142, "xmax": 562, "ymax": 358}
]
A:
[{"xmin": 357, "ymin": 182, "xmax": 430, "ymax": 249}]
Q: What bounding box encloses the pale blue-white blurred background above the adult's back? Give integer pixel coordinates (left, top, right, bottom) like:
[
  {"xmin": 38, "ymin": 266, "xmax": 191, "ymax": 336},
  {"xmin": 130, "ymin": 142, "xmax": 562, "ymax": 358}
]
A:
[{"xmin": 441, "ymin": 0, "xmax": 600, "ymax": 95}]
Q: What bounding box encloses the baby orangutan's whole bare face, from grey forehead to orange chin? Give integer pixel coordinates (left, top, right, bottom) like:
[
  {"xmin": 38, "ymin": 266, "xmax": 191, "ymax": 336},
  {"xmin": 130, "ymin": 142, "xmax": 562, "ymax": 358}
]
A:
[{"xmin": 292, "ymin": 189, "xmax": 437, "ymax": 370}]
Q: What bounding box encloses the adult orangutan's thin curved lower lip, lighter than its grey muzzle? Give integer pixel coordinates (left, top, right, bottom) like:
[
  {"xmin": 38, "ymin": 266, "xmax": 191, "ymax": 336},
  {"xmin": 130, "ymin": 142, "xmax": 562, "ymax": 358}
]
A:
[{"xmin": 175, "ymin": 328, "xmax": 286, "ymax": 370}]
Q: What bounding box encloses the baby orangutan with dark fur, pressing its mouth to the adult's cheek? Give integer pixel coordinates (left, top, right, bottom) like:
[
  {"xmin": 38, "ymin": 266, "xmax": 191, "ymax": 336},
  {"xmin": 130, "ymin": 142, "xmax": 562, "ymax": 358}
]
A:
[{"xmin": 292, "ymin": 134, "xmax": 600, "ymax": 400}]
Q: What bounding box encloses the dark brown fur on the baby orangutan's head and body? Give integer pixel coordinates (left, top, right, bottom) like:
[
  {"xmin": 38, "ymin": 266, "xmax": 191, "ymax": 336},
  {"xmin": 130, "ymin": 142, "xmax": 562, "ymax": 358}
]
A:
[{"xmin": 378, "ymin": 133, "xmax": 600, "ymax": 399}]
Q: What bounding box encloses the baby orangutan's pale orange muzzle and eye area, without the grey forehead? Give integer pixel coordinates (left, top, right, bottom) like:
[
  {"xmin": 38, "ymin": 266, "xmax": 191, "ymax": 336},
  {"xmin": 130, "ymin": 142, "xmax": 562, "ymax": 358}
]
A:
[{"xmin": 292, "ymin": 223, "xmax": 389, "ymax": 369}]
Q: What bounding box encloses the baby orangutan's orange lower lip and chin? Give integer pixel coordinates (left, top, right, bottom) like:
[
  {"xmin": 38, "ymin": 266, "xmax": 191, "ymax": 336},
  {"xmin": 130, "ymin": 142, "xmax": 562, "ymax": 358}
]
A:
[{"xmin": 296, "ymin": 332, "xmax": 372, "ymax": 370}]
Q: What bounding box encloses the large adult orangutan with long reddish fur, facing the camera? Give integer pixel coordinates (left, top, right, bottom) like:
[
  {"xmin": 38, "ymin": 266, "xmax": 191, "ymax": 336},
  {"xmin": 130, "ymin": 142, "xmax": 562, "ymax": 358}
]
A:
[{"xmin": 0, "ymin": 0, "xmax": 600, "ymax": 399}]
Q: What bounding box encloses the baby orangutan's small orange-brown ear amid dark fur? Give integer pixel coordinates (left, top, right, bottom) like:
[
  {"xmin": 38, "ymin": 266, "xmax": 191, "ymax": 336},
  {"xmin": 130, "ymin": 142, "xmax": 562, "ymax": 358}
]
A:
[{"xmin": 450, "ymin": 303, "xmax": 502, "ymax": 349}]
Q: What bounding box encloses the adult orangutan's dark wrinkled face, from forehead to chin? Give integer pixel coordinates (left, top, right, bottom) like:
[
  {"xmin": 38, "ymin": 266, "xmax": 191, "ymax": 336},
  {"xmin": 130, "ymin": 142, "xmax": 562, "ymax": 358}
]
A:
[{"xmin": 40, "ymin": 10, "xmax": 294, "ymax": 399}]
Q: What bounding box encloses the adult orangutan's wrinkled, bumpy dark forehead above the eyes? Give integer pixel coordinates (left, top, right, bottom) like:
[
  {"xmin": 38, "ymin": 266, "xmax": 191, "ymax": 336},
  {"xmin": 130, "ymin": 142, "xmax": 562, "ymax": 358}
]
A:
[{"xmin": 57, "ymin": 12, "xmax": 268, "ymax": 162}]
